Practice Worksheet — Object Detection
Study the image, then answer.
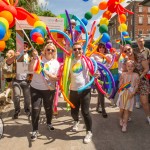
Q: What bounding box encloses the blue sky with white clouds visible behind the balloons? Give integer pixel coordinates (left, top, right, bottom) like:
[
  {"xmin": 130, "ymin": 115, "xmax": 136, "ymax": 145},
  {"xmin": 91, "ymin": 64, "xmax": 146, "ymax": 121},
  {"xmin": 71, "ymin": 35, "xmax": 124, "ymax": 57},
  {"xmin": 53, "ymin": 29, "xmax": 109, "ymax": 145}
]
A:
[{"xmin": 38, "ymin": 0, "xmax": 127, "ymax": 37}]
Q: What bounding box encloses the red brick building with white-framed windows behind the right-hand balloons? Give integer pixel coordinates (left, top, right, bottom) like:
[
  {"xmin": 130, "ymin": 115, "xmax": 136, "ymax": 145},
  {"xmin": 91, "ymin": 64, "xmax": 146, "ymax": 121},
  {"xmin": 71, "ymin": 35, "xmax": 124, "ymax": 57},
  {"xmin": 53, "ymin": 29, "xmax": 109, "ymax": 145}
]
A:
[{"xmin": 109, "ymin": 0, "xmax": 150, "ymax": 47}]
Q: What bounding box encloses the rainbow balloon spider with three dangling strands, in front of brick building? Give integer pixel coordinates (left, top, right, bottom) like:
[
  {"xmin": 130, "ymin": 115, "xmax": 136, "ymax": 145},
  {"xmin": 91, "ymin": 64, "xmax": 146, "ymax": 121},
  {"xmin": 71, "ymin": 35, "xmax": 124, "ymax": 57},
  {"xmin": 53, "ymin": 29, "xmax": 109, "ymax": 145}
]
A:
[{"xmin": 82, "ymin": 0, "xmax": 133, "ymax": 47}]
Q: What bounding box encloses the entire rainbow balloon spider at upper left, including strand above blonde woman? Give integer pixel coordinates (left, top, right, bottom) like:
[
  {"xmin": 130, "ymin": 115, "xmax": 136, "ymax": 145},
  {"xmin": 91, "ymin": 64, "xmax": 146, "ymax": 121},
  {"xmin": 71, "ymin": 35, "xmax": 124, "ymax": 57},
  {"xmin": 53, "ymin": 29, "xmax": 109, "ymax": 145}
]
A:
[{"xmin": 0, "ymin": 0, "xmax": 46, "ymax": 51}]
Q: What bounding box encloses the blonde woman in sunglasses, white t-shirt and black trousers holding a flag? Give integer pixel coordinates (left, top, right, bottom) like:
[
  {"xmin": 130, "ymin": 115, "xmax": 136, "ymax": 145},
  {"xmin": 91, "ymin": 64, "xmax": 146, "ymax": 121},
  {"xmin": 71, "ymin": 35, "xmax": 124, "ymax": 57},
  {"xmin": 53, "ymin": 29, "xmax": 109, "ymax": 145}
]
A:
[{"xmin": 30, "ymin": 43, "xmax": 59, "ymax": 140}]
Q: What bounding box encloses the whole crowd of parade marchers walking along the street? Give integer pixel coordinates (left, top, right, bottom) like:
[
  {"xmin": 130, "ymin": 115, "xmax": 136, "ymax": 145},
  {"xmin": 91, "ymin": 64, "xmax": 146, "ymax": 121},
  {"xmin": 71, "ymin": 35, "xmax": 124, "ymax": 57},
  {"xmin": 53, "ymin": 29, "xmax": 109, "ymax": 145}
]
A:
[{"xmin": 0, "ymin": 32, "xmax": 150, "ymax": 143}]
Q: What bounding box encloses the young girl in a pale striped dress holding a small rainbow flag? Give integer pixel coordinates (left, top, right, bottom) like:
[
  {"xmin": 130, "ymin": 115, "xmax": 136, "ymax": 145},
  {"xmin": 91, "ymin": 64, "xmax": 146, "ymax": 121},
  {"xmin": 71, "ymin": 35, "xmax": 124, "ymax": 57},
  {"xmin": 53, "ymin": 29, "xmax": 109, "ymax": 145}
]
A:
[{"xmin": 117, "ymin": 60, "xmax": 139, "ymax": 132}]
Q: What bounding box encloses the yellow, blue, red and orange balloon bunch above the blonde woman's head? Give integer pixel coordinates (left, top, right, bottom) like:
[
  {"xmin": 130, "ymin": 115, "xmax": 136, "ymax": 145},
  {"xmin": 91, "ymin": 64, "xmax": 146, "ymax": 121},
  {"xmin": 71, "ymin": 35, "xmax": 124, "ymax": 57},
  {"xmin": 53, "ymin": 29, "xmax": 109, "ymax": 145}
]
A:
[{"xmin": 30, "ymin": 21, "xmax": 47, "ymax": 44}]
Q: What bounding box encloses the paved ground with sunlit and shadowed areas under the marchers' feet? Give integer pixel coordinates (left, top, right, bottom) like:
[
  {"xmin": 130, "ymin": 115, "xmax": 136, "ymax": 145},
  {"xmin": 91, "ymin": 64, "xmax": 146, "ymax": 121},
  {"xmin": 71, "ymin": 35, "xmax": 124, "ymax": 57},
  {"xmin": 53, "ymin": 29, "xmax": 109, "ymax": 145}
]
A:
[{"xmin": 0, "ymin": 94, "xmax": 150, "ymax": 150}]
